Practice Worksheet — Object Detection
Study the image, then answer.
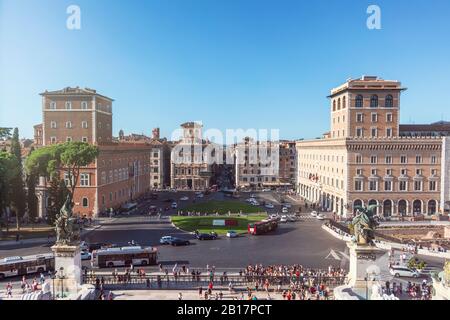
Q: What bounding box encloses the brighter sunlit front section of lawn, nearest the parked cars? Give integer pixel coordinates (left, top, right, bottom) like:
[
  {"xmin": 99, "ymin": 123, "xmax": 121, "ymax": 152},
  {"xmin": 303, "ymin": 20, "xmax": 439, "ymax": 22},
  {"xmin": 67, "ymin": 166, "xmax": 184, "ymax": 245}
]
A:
[{"xmin": 172, "ymin": 214, "xmax": 267, "ymax": 235}]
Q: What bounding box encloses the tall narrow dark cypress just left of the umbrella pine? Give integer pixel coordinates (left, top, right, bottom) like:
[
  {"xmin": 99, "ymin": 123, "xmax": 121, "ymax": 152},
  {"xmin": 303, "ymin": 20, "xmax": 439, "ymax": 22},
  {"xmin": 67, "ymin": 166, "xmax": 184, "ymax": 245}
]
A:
[{"xmin": 11, "ymin": 128, "xmax": 26, "ymax": 230}]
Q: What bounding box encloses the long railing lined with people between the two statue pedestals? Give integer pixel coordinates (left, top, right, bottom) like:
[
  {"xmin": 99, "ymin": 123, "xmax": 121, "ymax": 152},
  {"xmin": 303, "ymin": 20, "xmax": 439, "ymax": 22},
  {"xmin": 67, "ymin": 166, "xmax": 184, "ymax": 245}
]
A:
[{"xmin": 83, "ymin": 274, "xmax": 346, "ymax": 289}]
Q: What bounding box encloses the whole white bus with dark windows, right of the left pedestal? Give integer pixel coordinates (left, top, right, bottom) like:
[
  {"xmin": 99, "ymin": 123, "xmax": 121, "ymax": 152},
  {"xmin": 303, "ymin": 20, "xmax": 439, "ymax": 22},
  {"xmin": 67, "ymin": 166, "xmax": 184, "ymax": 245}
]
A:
[{"xmin": 91, "ymin": 246, "xmax": 158, "ymax": 268}]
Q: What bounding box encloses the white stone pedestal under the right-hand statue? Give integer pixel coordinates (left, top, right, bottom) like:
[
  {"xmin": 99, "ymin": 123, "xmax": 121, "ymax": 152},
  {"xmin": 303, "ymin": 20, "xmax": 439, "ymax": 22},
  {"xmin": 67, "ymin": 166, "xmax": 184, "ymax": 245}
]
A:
[{"xmin": 347, "ymin": 242, "xmax": 385, "ymax": 289}]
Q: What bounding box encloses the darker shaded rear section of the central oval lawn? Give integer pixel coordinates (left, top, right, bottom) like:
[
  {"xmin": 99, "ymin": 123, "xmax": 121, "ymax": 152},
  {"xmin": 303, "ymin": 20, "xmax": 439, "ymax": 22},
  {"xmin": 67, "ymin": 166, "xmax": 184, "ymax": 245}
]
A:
[{"xmin": 182, "ymin": 201, "xmax": 264, "ymax": 214}]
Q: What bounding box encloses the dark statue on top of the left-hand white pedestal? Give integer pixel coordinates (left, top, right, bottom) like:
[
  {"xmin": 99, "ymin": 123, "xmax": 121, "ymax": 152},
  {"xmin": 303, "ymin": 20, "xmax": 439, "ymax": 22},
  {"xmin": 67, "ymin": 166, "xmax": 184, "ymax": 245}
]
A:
[{"xmin": 55, "ymin": 195, "xmax": 80, "ymax": 245}]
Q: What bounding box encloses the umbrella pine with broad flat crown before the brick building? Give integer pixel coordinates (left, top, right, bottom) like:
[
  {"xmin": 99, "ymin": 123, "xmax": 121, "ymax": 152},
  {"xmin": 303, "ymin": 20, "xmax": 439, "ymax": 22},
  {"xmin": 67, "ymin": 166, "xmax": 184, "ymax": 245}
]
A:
[{"xmin": 25, "ymin": 142, "xmax": 98, "ymax": 206}]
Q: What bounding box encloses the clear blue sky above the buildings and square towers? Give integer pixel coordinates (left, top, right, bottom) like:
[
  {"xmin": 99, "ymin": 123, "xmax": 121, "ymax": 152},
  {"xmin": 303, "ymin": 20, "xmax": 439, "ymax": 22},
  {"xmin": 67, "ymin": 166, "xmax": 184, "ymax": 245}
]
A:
[{"xmin": 0, "ymin": 0, "xmax": 450, "ymax": 139}]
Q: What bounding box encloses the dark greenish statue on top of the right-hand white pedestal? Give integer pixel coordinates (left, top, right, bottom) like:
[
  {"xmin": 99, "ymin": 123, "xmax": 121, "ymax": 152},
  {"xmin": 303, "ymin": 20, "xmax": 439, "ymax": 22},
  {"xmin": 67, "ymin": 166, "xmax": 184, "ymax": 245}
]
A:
[{"xmin": 352, "ymin": 205, "xmax": 378, "ymax": 244}]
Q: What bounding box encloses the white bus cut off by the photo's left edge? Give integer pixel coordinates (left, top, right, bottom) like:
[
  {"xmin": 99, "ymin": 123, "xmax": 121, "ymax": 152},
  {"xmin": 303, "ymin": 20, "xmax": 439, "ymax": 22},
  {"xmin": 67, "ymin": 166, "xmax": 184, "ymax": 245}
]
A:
[{"xmin": 0, "ymin": 253, "xmax": 55, "ymax": 280}]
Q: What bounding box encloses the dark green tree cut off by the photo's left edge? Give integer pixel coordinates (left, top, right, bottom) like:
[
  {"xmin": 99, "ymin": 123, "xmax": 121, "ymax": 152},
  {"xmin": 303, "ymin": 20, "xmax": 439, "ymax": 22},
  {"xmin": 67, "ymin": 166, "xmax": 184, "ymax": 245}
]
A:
[{"xmin": 0, "ymin": 151, "xmax": 18, "ymax": 231}]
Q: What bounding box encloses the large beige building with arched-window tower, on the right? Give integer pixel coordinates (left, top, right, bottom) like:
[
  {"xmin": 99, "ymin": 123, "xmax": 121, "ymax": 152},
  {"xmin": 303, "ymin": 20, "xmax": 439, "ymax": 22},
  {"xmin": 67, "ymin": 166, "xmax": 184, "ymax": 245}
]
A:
[{"xmin": 296, "ymin": 76, "xmax": 443, "ymax": 217}]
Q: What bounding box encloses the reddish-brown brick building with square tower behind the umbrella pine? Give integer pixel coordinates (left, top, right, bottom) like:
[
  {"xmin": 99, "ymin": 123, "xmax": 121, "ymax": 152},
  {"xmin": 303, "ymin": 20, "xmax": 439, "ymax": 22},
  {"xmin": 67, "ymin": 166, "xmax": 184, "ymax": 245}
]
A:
[{"xmin": 34, "ymin": 87, "xmax": 163, "ymax": 216}]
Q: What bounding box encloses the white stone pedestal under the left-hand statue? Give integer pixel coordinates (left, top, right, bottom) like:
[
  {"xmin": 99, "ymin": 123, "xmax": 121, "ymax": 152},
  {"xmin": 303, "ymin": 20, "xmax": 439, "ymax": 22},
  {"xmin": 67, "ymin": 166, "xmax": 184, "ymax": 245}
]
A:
[{"xmin": 52, "ymin": 244, "xmax": 82, "ymax": 297}]
